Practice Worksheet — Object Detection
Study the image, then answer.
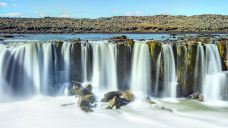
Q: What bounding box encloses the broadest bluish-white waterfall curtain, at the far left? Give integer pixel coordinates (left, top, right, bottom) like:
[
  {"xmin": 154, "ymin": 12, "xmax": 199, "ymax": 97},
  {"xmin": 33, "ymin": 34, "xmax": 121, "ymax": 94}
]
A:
[{"xmin": 0, "ymin": 42, "xmax": 71, "ymax": 95}]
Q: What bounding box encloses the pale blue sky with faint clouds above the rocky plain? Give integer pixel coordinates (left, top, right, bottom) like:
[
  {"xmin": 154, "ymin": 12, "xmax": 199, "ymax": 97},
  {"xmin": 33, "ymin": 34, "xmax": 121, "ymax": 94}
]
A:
[{"xmin": 0, "ymin": 0, "xmax": 228, "ymax": 18}]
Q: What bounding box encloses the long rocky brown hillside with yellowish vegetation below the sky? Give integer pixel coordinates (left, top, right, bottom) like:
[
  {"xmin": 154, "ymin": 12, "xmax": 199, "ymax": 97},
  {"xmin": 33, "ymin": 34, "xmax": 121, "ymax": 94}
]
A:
[{"xmin": 0, "ymin": 15, "xmax": 228, "ymax": 33}]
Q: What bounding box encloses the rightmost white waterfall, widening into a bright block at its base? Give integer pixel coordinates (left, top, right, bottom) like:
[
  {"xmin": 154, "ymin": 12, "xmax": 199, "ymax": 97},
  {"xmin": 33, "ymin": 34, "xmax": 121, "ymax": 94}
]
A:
[{"xmin": 203, "ymin": 44, "xmax": 227, "ymax": 101}]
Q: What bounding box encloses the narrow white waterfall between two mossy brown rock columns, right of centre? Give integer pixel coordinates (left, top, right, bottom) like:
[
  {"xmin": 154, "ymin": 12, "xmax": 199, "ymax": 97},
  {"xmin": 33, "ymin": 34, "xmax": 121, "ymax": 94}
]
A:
[{"xmin": 162, "ymin": 44, "xmax": 177, "ymax": 98}]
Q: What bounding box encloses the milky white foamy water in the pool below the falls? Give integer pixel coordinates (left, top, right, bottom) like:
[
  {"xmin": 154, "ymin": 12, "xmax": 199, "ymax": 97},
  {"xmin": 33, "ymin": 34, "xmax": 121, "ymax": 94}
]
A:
[{"xmin": 0, "ymin": 97, "xmax": 228, "ymax": 128}]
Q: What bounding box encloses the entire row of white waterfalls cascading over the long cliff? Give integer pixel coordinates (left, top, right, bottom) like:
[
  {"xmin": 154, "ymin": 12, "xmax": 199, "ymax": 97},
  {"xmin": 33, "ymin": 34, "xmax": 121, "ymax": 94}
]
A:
[{"xmin": 0, "ymin": 40, "xmax": 228, "ymax": 101}]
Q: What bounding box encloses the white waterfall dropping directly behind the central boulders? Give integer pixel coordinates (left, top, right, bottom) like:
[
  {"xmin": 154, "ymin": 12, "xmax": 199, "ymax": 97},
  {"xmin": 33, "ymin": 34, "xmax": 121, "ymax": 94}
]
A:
[{"xmin": 91, "ymin": 41, "xmax": 118, "ymax": 91}]
